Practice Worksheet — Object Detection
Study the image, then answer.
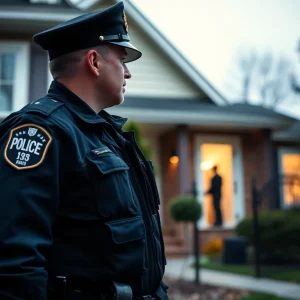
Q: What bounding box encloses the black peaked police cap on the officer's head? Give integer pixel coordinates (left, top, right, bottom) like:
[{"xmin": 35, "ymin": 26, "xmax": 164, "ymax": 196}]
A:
[{"xmin": 33, "ymin": 2, "xmax": 142, "ymax": 62}]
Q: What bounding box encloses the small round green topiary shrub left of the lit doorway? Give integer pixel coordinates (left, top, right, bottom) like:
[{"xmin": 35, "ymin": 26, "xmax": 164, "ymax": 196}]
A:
[{"xmin": 169, "ymin": 196, "xmax": 201, "ymax": 222}]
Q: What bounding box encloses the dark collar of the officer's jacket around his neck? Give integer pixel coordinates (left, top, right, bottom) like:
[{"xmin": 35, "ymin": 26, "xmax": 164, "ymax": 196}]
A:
[{"xmin": 48, "ymin": 80, "xmax": 127, "ymax": 131}]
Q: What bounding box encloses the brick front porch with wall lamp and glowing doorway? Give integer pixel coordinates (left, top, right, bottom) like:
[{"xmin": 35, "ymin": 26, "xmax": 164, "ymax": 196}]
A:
[{"xmin": 159, "ymin": 126, "xmax": 275, "ymax": 257}]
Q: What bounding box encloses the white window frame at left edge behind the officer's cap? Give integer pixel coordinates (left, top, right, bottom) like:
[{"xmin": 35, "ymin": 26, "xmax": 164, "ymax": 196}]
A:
[{"xmin": 0, "ymin": 41, "xmax": 30, "ymax": 118}]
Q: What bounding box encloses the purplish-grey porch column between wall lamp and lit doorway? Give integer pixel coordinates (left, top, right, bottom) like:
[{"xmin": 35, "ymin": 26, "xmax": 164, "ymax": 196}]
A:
[{"xmin": 177, "ymin": 125, "xmax": 191, "ymax": 194}]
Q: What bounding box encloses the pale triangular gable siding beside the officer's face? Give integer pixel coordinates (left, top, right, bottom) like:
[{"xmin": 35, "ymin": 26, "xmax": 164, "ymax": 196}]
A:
[{"xmin": 126, "ymin": 24, "xmax": 202, "ymax": 99}]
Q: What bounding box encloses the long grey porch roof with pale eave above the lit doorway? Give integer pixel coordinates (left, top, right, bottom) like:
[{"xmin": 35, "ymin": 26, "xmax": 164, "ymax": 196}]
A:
[{"xmin": 108, "ymin": 97, "xmax": 295, "ymax": 130}]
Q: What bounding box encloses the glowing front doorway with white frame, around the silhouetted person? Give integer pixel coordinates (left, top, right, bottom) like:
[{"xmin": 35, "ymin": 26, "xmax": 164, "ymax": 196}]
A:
[{"xmin": 196, "ymin": 135, "xmax": 245, "ymax": 228}]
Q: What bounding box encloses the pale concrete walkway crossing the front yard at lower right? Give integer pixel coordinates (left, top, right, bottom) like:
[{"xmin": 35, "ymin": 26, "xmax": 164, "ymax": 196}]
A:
[{"xmin": 165, "ymin": 259, "xmax": 300, "ymax": 299}]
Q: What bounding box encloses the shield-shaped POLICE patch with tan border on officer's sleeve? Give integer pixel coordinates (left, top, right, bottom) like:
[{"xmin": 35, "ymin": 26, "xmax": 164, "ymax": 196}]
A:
[{"xmin": 4, "ymin": 124, "xmax": 52, "ymax": 170}]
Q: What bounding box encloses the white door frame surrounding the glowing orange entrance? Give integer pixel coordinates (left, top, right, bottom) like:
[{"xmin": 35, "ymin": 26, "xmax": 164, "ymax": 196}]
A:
[{"xmin": 194, "ymin": 134, "xmax": 245, "ymax": 230}]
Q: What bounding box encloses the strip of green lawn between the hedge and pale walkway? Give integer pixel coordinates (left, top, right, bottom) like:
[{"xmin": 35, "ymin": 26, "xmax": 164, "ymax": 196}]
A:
[{"xmin": 196, "ymin": 256, "xmax": 300, "ymax": 283}]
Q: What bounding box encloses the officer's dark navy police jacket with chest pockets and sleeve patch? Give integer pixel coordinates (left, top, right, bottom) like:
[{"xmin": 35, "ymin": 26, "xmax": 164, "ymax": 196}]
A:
[{"xmin": 0, "ymin": 81, "xmax": 167, "ymax": 300}]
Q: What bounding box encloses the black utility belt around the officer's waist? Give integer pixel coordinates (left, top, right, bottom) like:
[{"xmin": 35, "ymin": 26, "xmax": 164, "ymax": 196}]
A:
[{"xmin": 48, "ymin": 276, "xmax": 168, "ymax": 300}]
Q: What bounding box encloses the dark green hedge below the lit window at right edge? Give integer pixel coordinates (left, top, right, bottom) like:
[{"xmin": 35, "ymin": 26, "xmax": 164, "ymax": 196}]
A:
[{"xmin": 236, "ymin": 211, "xmax": 300, "ymax": 264}]
